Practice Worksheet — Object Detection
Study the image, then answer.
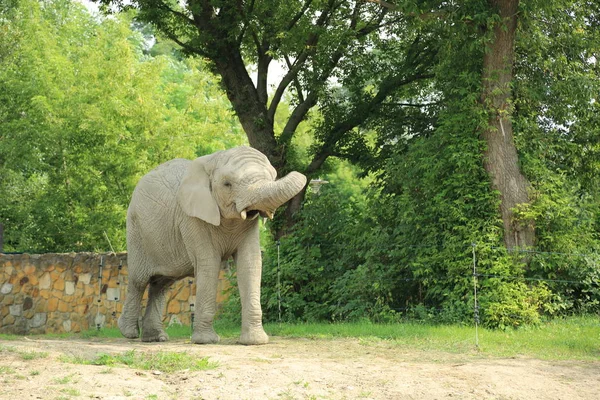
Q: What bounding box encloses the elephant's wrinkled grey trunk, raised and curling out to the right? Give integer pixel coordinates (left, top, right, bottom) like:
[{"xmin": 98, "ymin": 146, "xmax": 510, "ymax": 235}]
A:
[{"xmin": 238, "ymin": 171, "xmax": 306, "ymax": 216}]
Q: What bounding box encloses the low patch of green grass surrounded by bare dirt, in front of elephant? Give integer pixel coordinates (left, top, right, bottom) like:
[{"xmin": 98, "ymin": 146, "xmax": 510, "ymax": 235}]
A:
[{"xmin": 61, "ymin": 350, "xmax": 218, "ymax": 373}]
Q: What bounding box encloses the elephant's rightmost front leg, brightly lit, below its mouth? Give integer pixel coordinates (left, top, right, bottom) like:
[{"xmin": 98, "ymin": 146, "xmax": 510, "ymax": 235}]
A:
[{"xmin": 235, "ymin": 223, "xmax": 269, "ymax": 344}]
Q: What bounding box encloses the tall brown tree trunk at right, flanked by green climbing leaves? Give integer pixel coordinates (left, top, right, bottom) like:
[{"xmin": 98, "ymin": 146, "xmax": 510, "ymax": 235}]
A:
[{"xmin": 481, "ymin": 0, "xmax": 535, "ymax": 248}]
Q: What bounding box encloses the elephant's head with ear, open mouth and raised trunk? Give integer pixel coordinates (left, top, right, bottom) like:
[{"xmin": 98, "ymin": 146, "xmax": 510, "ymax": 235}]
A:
[{"xmin": 177, "ymin": 147, "xmax": 306, "ymax": 226}]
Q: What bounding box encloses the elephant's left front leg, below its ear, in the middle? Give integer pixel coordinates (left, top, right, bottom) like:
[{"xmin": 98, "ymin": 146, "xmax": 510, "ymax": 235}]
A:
[{"xmin": 192, "ymin": 257, "xmax": 221, "ymax": 344}]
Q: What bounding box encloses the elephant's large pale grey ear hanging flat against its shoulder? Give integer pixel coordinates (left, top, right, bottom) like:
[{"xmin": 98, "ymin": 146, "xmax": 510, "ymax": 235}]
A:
[{"xmin": 177, "ymin": 155, "xmax": 221, "ymax": 226}]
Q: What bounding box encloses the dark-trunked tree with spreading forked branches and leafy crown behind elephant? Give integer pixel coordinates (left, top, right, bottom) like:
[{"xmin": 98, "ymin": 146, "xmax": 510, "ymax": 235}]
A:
[{"xmin": 97, "ymin": 0, "xmax": 436, "ymax": 235}]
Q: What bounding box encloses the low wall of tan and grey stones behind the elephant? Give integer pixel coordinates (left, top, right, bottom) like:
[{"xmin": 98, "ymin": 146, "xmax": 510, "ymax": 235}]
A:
[{"xmin": 0, "ymin": 253, "xmax": 229, "ymax": 334}]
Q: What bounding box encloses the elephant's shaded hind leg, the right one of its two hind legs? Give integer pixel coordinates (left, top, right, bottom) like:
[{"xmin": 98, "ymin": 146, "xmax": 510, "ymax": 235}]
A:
[{"xmin": 142, "ymin": 276, "xmax": 173, "ymax": 342}]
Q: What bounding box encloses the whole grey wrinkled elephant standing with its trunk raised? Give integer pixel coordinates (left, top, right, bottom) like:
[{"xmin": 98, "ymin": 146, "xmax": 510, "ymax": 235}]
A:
[{"xmin": 119, "ymin": 147, "xmax": 306, "ymax": 344}]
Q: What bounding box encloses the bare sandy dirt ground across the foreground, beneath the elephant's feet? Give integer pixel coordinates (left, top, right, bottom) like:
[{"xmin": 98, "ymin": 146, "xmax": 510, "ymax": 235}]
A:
[{"xmin": 0, "ymin": 337, "xmax": 600, "ymax": 400}]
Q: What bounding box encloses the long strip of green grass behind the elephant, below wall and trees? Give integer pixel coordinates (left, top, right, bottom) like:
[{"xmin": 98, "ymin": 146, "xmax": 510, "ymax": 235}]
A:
[{"xmin": 0, "ymin": 316, "xmax": 600, "ymax": 360}]
